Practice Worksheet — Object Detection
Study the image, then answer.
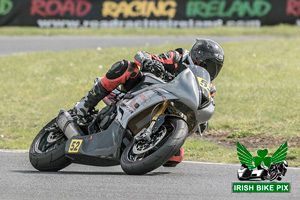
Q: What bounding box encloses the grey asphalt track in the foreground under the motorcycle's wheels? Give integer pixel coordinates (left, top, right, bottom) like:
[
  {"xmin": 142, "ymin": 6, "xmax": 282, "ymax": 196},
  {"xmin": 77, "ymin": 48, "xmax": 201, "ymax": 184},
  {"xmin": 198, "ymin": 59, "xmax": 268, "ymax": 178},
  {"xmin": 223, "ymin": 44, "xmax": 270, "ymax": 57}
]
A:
[{"xmin": 0, "ymin": 152, "xmax": 300, "ymax": 200}]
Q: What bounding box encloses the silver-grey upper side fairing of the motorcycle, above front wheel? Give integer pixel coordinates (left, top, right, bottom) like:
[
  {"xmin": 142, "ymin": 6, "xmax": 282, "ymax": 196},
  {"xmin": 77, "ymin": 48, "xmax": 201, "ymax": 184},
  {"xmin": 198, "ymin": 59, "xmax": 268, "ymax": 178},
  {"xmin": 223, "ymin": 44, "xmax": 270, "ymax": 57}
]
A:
[{"xmin": 117, "ymin": 69, "xmax": 200, "ymax": 128}]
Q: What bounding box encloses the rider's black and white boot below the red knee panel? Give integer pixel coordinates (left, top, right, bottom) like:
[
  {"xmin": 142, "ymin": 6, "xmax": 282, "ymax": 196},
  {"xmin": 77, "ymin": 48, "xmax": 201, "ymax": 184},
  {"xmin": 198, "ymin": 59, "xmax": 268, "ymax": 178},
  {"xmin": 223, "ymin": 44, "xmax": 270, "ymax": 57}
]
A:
[{"xmin": 74, "ymin": 81, "xmax": 110, "ymax": 118}]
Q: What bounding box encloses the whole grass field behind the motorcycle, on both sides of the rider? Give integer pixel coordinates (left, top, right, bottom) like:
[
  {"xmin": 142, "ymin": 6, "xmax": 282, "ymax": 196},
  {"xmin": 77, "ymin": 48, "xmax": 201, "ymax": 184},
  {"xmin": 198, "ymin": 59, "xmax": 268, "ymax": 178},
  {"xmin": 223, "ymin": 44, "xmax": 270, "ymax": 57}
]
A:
[{"xmin": 0, "ymin": 35, "xmax": 300, "ymax": 166}]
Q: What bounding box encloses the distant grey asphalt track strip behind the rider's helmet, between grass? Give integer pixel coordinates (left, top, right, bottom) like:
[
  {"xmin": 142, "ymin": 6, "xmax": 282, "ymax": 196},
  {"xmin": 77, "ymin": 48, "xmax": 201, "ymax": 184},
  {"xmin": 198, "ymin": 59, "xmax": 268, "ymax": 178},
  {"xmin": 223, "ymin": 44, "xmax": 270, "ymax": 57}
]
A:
[{"xmin": 0, "ymin": 36, "xmax": 269, "ymax": 56}]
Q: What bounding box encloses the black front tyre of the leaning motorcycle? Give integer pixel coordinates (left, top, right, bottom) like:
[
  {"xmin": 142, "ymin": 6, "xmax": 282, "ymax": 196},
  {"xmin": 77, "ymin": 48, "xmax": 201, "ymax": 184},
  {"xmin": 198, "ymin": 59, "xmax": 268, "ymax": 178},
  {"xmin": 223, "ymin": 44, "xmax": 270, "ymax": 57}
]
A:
[{"xmin": 121, "ymin": 117, "xmax": 188, "ymax": 175}]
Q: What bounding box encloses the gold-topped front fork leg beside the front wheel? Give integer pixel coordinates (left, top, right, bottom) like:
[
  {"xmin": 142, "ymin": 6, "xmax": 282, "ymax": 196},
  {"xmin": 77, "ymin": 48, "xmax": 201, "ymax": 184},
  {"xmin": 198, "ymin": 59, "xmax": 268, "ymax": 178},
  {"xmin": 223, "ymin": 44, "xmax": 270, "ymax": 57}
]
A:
[{"xmin": 136, "ymin": 101, "xmax": 169, "ymax": 142}]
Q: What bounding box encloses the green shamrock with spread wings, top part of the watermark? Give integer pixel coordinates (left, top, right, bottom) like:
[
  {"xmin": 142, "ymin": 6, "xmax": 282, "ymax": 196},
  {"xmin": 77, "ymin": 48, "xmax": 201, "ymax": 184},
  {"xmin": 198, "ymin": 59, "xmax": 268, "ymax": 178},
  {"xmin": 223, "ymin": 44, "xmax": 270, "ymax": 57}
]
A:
[{"xmin": 237, "ymin": 142, "xmax": 288, "ymax": 170}]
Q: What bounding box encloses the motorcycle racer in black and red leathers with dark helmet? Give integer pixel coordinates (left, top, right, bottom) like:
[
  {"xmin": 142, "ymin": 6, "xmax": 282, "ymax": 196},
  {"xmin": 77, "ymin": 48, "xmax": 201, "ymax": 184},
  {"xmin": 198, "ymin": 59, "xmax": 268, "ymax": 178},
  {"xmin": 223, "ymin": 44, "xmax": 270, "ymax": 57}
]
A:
[{"xmin": 74, "ymin": 39, "xmax": 224, "ymax": 166}]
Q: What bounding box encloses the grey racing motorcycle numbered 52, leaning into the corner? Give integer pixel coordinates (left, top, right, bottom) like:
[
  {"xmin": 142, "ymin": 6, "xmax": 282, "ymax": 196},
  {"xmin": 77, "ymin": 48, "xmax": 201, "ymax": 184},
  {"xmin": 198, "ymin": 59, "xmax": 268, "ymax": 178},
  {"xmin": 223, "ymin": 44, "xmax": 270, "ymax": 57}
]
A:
[{"xmin": 29, "ymin": 66, "xmax": 215, "ymax": 175}]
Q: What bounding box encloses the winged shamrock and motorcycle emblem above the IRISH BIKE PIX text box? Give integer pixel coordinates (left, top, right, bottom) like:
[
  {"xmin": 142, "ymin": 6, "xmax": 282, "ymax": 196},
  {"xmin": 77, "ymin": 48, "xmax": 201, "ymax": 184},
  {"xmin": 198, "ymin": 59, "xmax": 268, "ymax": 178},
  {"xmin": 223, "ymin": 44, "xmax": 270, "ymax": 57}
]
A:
[{"xmin": 237, "ymin": 142, "xmax": 288, "ymax": 181}]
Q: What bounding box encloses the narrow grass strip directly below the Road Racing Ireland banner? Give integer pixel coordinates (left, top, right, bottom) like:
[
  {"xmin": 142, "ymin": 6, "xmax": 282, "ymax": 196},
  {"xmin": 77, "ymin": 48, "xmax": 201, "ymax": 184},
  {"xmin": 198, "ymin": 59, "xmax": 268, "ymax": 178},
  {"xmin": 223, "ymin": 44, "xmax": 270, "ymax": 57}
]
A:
[{"xmin": 0, "ymin": 25, "xmax": 300, "ymax": 37}]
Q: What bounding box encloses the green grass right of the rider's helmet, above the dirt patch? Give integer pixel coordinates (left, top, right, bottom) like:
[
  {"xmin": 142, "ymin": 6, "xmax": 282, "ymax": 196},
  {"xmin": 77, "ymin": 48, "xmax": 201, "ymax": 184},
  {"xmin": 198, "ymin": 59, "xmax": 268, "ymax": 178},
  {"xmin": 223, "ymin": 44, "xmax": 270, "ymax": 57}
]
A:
[{"xmin": 211, "ymin": 39, "xmax": 300, "ymax": 137}]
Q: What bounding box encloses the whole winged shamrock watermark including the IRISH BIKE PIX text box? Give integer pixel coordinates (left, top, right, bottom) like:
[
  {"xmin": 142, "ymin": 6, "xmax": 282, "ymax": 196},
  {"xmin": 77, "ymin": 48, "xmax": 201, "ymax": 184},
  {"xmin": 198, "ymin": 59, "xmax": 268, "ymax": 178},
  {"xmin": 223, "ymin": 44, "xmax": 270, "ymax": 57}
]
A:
[{"xmin": 232, "ymin": 142, "xmax": 290, "ymax": 193}]
